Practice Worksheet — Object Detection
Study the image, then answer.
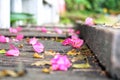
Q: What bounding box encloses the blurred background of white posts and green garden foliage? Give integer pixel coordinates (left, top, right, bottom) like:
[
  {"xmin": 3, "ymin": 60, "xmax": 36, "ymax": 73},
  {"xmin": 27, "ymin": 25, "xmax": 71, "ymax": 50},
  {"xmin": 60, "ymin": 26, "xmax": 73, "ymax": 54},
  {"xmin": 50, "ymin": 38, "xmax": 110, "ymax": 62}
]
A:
[{"xmin": 0, "ymin": 0, "xmax": 120, "ymax": 28}]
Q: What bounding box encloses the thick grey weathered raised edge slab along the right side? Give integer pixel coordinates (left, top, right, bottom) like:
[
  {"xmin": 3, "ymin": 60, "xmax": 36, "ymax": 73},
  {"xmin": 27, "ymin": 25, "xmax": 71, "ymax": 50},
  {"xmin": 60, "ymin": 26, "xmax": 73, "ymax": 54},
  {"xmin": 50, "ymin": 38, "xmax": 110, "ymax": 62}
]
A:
[{"xmin": 76, "ymin": 23, "xmax": 120, "ymax": 79}]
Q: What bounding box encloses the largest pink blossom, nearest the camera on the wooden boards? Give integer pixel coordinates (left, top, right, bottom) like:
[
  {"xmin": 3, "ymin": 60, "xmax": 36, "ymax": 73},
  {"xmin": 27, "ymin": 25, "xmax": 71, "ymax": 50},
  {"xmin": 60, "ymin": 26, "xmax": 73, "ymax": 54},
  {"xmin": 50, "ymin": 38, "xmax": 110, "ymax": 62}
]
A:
[{"xmin": 51, "ymin": 53, "xmax": 72, "ymax": 71}]
